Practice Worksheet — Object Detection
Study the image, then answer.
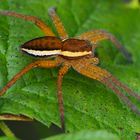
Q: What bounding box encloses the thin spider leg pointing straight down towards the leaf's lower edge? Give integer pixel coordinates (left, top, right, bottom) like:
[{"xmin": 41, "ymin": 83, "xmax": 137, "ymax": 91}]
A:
[{"xmin": 57, "ymin": 65, "xmax": 70, "ymax": 131}]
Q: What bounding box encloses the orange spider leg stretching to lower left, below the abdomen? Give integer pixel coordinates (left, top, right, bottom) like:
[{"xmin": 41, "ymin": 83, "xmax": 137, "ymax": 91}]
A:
[{"xmin": 0, "ymin": 60, "xmax": 60, "ymax": 96}]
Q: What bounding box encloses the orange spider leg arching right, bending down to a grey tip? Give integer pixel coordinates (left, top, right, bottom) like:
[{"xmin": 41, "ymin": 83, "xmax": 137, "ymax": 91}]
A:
[{"xmin": 78, "ymin": 30, "xmax": 132, "ymax": 62}]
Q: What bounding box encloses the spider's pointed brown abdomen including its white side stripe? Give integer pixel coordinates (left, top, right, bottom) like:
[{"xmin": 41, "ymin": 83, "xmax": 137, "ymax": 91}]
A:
[{"xmin": 21, "ymin": 36, "xmax": 62, "ymax": 57}]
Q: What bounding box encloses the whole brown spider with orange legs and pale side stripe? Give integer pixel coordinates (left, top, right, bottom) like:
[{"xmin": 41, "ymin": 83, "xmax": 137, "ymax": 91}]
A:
[{"xmin": 0, "ymin": 8, "xmax": 140, "ymax": 130}]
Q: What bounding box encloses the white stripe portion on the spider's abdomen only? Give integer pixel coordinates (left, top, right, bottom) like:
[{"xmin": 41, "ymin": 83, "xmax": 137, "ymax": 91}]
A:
[{"xmin": 22, "ymin": 48, "xmax": 61, "ymax": 56}]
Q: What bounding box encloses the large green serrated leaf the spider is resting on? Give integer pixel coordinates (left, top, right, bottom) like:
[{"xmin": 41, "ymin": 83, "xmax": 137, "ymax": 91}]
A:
[{"xmin": 0, "ymin": 0, "xmax": 140, "ymax": 140}]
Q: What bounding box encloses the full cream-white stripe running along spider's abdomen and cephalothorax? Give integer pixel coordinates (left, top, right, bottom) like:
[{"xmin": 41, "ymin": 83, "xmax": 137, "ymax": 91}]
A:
[{"xmin": 22, "ymin": 48, "xmax": 92, "ymax": 57}]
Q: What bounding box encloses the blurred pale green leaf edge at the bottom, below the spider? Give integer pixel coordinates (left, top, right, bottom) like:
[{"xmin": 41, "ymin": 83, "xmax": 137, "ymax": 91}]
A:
[{"xmin": 43, "ymin": 130, "xmax": 119, "ymax": 140}]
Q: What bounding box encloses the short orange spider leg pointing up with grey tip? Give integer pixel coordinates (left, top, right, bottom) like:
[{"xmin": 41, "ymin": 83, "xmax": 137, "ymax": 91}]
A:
[{"xmin": 49, "ymin": 7, "xmax": 68, "ymax": 39}]
